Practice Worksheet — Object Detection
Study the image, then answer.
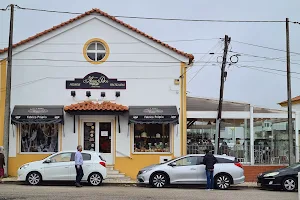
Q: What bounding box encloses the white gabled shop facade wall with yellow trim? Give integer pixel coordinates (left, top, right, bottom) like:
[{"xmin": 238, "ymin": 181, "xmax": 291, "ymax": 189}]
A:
[{"xmin": 9, "ymin": 17, "xmax": 186, "ymax": 178}]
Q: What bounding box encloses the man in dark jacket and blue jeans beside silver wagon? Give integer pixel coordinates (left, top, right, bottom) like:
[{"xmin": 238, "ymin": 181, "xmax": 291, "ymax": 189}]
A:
[{"xmin": 203, "ymin": 149, "xmax": 217, "ymax": 190}]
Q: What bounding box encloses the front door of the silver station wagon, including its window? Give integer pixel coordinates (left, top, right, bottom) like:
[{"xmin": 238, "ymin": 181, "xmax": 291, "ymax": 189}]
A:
[{"xmin": 169, "ymin": 156, "xmax": 200, "ymax": 184}]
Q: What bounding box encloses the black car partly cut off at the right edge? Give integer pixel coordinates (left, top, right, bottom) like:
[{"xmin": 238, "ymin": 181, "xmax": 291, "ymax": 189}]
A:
[{"xmin": 257, "ymin": 163, "xmax": 300, "ymax": 191}]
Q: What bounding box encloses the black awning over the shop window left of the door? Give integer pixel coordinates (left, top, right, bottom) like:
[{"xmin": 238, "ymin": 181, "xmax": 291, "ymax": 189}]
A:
[{"xmin": 11, "ymin": 105, "xmax": 64, "ymax": 124}]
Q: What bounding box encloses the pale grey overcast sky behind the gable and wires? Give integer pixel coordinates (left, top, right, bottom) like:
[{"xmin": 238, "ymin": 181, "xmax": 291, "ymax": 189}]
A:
[{"xmin": 0, "ymin": 0, "xmax": 300, "ymax": 108}]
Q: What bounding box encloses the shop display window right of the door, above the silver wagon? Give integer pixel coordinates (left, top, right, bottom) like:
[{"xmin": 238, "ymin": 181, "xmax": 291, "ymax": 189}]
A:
[{"xmin": 134, "ymin": 124, "xmax": 170, "ymax": 152}]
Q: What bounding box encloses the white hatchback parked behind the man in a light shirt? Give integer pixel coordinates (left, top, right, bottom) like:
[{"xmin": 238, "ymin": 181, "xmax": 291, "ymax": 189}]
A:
[{"xmin": 18, "ymin": 151, "xmax": 107, "ymax": 186}]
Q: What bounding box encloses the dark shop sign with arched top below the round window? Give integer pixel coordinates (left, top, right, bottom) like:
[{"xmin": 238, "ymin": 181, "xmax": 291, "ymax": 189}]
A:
[{"xmin": 66, "ymin": 72, "xmax": 126, "ymax": 89}]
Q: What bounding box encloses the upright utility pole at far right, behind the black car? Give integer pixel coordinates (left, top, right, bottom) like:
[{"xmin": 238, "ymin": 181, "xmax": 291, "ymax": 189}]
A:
[{"xmin": 285, "ymin": 18, "xmax": 292, "ymax": 165}]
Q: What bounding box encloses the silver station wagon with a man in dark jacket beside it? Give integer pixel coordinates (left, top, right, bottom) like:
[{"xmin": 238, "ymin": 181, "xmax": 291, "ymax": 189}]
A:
[{"xmin": 137, "ymin": 154, "xmax": 245, "ymax": 190}]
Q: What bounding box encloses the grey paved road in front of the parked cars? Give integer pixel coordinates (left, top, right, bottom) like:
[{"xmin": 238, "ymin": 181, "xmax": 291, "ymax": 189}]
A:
[{"xmin": 0, "ymin": 184, "xmax": 297, "ymax": 200}]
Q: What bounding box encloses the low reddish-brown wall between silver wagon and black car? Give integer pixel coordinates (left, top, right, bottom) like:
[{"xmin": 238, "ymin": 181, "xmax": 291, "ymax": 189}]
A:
[{"xmin": 243, "ymin": 165, "xmax": 285, "ymax": 182}]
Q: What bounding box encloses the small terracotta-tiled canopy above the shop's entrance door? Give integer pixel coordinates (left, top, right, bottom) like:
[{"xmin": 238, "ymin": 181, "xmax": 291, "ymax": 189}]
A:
[{"xmin": 64, "ymin": 101, "xmax": 128, "ymax": 112}]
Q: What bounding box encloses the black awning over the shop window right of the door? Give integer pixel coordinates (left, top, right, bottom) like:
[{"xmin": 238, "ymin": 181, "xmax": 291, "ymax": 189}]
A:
[{"xmin": 129, "ymin": 106, "xmax": 179, "ymax": 124}]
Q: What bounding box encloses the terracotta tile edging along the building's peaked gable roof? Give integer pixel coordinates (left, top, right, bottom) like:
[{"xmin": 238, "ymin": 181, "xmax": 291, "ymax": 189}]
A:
[{"xmin": 0, "ymin": 8, "xmax": 194, "ymax": 62}]
